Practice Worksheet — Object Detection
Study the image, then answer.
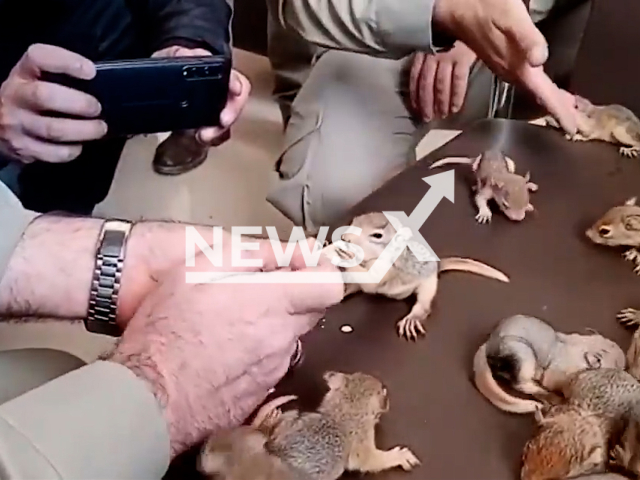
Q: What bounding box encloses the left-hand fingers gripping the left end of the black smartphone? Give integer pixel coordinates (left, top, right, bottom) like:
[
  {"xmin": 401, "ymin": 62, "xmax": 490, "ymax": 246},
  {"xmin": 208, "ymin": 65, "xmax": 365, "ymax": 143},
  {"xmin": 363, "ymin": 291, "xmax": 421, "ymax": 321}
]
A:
[{"xmin": 0, "ymin": 44, "xmax": 107, "ymax": 163}]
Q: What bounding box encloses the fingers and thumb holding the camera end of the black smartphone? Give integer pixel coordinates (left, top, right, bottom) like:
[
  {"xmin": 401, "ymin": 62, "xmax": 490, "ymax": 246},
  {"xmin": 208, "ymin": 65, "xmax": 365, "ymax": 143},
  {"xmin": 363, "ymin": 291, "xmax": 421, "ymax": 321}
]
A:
[{"xmin": 152, "ymin": 46, "xmax": 251, "ymax": 146}]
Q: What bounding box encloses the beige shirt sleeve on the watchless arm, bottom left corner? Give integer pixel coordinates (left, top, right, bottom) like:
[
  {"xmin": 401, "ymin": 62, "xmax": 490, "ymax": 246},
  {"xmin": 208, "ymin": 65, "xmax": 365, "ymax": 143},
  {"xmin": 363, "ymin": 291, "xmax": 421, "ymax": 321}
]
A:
[{"xmin": 0, "ymin": 361, "xmax": 170, "ymax": 480}]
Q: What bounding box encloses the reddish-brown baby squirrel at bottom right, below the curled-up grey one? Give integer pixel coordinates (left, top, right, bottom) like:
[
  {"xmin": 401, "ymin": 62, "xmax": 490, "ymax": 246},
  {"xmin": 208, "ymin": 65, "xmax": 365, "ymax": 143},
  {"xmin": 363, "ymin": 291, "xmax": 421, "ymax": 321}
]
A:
[{"xmin": 521, "ymin": 368, "xmax": 640, "ymax": 480}]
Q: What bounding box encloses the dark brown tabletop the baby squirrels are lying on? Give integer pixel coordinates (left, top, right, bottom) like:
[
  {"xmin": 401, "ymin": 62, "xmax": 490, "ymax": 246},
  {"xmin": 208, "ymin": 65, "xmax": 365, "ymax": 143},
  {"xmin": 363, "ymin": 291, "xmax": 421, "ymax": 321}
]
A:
[{"xmin": 164, "ymin": 120, "xmax": 640, "ymax": 480}]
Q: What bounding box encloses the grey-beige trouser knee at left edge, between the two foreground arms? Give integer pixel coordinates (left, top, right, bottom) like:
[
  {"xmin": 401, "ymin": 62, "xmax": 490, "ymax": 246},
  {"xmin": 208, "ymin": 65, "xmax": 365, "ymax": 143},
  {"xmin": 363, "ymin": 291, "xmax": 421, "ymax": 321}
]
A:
[{"xmin": 0, "ymin": 348, "xmax": 85, "ymax": 404}]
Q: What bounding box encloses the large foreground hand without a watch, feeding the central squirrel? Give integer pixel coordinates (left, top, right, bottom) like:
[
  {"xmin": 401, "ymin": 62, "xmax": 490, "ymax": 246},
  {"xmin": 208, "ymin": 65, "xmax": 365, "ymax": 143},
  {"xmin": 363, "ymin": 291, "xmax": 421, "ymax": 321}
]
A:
[{"xmin": 107, "ymin": 236, "xmax": 344, "ymax": 456}]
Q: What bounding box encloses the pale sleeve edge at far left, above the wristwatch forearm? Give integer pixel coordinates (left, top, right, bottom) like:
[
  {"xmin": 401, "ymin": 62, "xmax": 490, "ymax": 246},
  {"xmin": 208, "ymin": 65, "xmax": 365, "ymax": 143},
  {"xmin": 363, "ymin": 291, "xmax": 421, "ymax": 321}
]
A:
[{"xmin": 0, "ymin": 182, "xmax": 38, "ymax": 279}]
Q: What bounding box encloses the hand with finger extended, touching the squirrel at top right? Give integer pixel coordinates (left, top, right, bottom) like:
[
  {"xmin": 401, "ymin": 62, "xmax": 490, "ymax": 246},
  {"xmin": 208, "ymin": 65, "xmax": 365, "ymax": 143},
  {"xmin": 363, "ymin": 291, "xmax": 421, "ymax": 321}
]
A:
[{"xmin": 433, "ymin": 0, "xmax": 577, "ymax": 134}]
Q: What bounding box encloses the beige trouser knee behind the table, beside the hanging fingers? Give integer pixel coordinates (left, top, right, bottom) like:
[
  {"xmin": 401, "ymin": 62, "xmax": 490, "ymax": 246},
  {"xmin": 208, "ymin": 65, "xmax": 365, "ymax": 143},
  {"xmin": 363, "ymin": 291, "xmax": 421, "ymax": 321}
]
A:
[{"xmin": 267, "ymin": 51, "xmax": 491, "ymax": 232}]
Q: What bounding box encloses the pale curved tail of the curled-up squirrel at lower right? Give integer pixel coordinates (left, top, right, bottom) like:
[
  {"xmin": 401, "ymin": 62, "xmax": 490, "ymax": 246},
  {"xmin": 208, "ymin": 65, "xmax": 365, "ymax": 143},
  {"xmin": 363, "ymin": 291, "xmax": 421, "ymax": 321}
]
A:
[{"xmin": 473, "ymin": 343, "xmax": 538, "ymax": 413}]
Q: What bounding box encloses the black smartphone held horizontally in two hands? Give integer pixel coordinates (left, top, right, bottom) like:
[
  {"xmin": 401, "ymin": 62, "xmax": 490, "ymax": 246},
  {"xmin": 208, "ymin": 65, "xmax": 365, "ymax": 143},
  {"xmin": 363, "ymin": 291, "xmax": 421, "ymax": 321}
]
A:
[{"xmin": 43, "ymin": 56, "xmax": 231, "ymax": 136}]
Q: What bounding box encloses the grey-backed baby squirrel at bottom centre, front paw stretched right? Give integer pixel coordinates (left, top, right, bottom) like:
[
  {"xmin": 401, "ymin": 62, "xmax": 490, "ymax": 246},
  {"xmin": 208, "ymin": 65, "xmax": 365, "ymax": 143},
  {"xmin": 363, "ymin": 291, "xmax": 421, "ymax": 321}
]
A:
[{"xmin": 267, "ymin": 372, "xmax": 420, "ymax": 480}]
